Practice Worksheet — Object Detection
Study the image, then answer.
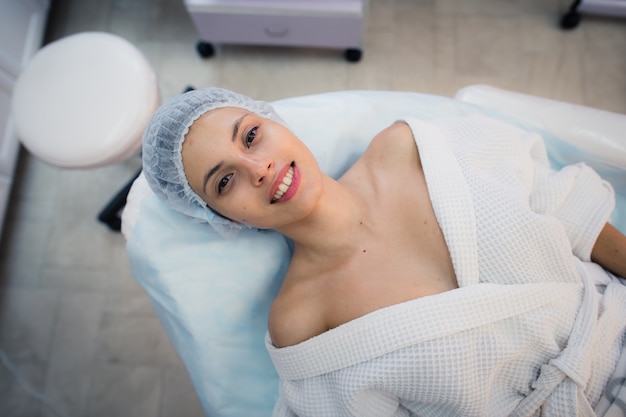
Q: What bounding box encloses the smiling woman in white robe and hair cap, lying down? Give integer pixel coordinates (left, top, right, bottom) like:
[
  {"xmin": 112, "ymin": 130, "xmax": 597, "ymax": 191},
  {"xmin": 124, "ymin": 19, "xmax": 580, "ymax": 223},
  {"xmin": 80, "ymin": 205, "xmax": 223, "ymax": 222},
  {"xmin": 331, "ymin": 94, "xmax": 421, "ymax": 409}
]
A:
[{"xmin": 143, "ymin": 88, "xmax": 626, "ymax": 416}]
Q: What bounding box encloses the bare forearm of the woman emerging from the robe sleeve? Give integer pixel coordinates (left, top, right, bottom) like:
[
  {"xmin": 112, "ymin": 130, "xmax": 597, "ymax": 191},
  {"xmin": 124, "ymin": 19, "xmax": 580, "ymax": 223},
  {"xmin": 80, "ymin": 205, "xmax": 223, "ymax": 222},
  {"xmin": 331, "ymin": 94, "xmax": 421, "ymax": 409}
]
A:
[{"xmin": 591, "ymin": 223, "xmax": 626, "ymax": 278}]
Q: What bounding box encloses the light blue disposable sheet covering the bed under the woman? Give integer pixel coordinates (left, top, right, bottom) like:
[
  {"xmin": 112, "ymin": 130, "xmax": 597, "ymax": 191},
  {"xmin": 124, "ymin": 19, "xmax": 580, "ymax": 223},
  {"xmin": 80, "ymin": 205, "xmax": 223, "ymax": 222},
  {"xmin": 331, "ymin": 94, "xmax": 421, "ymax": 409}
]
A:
[{"xmin": 124, "ymin": 91, "xmax": 620, "ymax": 417}]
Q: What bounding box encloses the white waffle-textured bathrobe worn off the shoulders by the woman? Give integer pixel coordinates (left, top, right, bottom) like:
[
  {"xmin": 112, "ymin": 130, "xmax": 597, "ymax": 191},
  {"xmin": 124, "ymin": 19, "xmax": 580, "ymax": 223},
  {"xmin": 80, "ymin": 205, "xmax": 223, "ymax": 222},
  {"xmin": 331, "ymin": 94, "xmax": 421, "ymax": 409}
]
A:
[{"xmin": 266, "ymin": 116, "xmax": 626, "ymax": 417}]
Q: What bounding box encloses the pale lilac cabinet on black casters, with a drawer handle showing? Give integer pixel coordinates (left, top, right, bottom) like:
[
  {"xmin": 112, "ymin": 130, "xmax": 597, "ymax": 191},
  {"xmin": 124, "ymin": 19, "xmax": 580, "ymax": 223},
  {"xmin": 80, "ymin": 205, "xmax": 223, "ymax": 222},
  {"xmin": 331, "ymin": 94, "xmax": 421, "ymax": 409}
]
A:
[{"xmin": 185, "ymin": 0, "xmax": 366, "ymax": 61}]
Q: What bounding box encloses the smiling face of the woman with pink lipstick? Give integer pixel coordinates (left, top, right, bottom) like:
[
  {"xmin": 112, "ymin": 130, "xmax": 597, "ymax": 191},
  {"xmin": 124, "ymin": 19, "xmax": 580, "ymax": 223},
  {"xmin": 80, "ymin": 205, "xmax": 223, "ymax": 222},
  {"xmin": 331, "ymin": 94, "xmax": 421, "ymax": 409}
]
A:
[{"xmin": 182, "ymin": 107, "xmax": 322, "ymax": 229}]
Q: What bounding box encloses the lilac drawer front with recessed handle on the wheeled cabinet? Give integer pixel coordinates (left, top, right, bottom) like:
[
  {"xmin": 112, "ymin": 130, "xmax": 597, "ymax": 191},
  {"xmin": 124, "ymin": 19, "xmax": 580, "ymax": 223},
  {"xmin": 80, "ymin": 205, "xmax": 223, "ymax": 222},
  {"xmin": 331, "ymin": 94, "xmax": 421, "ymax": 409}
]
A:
[{"xmin": 191, "ymin": 13, "xmax": 362, "ymax": 48}]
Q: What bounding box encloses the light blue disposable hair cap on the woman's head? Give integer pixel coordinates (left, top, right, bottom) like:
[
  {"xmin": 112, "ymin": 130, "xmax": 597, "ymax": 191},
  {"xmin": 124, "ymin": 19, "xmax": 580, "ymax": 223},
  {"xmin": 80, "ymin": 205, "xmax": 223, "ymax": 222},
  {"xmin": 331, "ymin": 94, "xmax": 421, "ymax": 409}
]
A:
[{"xmin": 142, "ymin": 87, "xmax": 284, "ymax": 238}]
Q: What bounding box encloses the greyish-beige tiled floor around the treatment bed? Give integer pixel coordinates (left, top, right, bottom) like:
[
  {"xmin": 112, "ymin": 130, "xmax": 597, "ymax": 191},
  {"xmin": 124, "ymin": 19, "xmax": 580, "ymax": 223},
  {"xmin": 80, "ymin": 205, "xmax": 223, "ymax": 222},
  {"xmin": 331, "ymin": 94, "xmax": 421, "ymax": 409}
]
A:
[{"xmin": 0, "ymin": 0, "xmax": 626, "ymax": 417}]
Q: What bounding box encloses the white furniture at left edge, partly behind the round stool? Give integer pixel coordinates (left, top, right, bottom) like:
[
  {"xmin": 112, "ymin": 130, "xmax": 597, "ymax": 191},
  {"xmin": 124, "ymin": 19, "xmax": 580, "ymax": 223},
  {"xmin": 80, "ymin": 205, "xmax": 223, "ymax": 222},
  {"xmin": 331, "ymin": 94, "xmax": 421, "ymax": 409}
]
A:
[{"xmin": 0, "ymin": 0, "xmax": 50, "ymax": 237}]
